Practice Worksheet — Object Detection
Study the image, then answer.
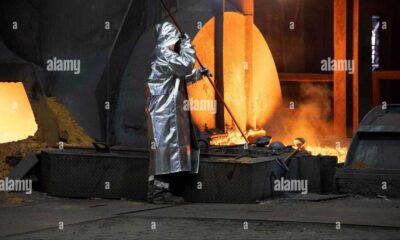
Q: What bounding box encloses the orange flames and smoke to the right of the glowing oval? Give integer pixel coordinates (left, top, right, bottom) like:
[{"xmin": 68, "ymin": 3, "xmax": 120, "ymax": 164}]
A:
[{"xmin": 268, "ymin": 84, "xmax": 348, "ymax": 163}]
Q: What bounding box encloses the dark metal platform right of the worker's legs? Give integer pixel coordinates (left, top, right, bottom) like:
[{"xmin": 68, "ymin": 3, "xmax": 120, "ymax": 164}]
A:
[{"xmin": 185, "ymin": 156, "xmax": 337, "ymax": 203}]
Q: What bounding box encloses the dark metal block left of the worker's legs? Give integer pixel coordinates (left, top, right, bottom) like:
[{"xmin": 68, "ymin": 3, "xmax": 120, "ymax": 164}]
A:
[{"xmin": 39, "ymin": 149, "xmax": 149, "ymax": 200}]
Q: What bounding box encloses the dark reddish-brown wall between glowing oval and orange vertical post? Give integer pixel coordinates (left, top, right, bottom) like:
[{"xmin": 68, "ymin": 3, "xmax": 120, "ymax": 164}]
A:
[{"xmin": 254, "ymin": 0, "xmax": 333, "ymax": 73}]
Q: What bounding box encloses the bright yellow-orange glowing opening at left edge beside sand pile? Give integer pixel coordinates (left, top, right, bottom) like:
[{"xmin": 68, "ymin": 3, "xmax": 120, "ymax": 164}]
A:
[{"xmin": 0, "ymin": 82, "xmax": 38, "ymax": 143}]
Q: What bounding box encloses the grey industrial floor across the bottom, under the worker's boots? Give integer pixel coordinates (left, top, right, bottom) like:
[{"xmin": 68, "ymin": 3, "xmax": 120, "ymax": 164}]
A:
[{"xmin": 0, "ymin": 192, "xmax": 400, "ymax": 240}]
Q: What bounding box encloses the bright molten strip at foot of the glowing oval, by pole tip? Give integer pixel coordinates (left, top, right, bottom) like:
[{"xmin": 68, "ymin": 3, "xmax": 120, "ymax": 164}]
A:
[{"xmin": 210, "ymin": 129, "xmax": 266, "ymax": 145}]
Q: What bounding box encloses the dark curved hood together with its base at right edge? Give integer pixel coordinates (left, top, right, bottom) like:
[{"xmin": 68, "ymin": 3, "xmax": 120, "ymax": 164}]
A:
[{"xmin": 336, "ymin": 105, "xmax": 400, "ymax": 197}]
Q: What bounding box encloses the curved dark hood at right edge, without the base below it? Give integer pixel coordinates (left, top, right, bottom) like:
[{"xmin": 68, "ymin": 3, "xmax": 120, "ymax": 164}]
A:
[{"xmin": 345, "ymin": 104, "xmax": 400, "ymax": 169}]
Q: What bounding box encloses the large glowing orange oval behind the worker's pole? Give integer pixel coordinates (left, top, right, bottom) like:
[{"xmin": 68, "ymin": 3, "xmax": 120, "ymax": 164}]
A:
[{"xmin": 188, "ymin": 12, "xmax": 281, "ymax": 133}]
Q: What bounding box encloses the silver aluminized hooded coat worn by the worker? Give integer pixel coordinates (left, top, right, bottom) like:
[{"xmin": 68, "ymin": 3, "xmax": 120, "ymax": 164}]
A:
[{"xmin": 146, "ymin": 22, "xmax": 201, "ymax": 175}]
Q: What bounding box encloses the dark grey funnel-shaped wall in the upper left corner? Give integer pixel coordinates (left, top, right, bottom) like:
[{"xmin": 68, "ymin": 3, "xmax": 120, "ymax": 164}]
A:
[{"xmin": 0, "ymin": 0, "xmax": 129, "ymax": 138}]
